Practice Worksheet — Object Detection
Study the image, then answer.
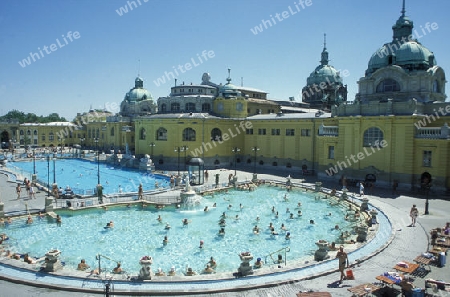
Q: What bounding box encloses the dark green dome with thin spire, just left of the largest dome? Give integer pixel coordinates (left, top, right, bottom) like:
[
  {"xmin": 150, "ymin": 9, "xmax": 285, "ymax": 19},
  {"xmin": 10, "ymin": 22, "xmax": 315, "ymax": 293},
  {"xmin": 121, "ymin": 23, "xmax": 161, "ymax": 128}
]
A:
[{"xmin": 302, "ymin": 34, "xmax": 347, "ymax": 110}]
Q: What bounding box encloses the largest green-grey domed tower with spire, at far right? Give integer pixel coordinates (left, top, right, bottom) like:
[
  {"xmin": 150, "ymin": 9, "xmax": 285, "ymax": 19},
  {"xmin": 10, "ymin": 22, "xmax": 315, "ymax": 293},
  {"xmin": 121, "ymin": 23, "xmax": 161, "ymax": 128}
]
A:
[{"xmin": 356, "ymin": 0, "xmax": 446, "ymax": 103}]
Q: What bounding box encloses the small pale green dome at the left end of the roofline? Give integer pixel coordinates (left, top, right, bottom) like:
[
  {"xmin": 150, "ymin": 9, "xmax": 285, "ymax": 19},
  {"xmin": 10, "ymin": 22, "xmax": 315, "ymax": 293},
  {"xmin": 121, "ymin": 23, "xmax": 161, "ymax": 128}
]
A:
[{"xmin": 120, "ymin": 76, "xmax": 156, "ymax": 117}]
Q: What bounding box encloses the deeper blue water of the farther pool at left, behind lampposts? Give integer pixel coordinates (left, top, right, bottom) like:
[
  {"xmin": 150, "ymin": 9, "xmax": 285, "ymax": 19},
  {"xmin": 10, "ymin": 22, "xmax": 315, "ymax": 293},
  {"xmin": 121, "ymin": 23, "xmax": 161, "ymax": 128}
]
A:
[{"xmin": 7, "ymin": 159, "xmax": 169, "ymax": 195}]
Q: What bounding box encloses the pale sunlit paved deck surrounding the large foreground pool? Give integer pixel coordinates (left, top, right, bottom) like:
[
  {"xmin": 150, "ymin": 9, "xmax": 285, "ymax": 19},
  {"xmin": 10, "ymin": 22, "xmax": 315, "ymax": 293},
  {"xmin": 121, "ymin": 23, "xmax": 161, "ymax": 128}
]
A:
[{"xmin": 0, "ymin": 165, "xmax": 450, "ymax": 297}]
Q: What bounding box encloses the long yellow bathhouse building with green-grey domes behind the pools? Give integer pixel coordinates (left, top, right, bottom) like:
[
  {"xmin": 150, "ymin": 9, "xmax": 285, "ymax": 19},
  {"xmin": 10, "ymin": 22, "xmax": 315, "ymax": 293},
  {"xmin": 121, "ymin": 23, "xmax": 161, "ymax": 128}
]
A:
[{"xmin": 0, "ymin": 3, "xmax": 450, "ymax": 192}]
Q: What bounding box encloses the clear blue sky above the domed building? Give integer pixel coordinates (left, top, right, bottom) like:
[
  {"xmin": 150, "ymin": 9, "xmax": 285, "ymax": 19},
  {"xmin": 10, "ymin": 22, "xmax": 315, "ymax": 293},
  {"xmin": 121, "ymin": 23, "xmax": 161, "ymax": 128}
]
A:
[{"xmin": 0, "ymin": 0, "xmax": 450, "ymax": 120}]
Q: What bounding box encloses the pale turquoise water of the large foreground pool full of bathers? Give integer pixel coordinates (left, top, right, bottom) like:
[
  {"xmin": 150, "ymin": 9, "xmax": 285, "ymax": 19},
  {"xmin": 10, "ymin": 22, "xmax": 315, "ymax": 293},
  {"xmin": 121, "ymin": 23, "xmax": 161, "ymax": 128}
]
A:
[{"xmin": 0, "ymin": 186, "xmax": 352, "ymax": 274}]
